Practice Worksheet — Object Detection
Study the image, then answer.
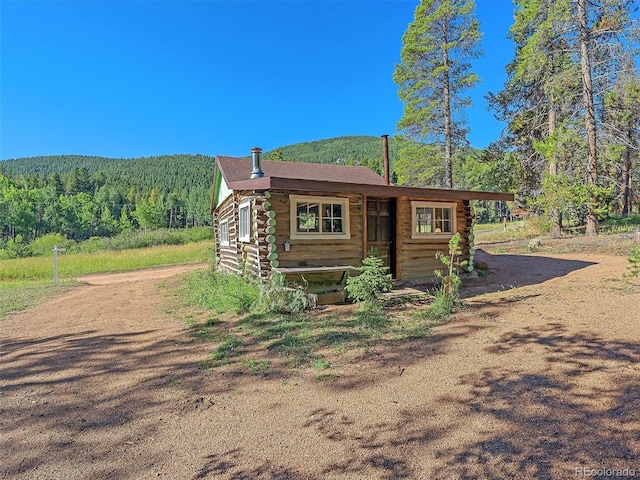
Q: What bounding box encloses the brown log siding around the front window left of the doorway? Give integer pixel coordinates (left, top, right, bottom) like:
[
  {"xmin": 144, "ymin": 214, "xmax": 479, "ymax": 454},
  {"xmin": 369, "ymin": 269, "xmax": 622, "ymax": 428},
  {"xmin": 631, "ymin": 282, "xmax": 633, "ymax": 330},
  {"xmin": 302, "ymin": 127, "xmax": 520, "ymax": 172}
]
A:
[{"xmin": 269, "ymin": 192, "xmax": 362, "ymax": 267}]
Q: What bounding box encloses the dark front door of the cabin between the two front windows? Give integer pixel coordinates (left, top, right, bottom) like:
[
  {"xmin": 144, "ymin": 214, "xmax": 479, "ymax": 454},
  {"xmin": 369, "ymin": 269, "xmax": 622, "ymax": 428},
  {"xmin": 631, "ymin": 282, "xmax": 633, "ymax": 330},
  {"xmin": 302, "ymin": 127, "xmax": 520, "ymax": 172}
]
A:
[{"xmin": 367, "ymin": 198, "xmax": 396, "ymax": 278}]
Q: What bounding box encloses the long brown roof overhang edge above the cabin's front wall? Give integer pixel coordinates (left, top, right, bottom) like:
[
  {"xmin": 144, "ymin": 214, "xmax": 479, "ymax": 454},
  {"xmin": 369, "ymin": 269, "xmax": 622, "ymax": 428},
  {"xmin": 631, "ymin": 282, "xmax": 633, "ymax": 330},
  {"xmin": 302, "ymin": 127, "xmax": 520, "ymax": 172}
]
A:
[{"xmin": 228, "ymin": 177, "xmax": 514, "ymax": 201}]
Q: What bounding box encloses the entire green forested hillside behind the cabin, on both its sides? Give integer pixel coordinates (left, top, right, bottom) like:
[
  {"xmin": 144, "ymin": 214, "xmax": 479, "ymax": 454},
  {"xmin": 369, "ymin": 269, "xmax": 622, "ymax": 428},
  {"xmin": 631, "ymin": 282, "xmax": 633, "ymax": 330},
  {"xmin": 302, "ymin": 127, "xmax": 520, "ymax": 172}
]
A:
[{"xmin": 0, "ymin": 122, "xmax": 637, "ymax": 257}]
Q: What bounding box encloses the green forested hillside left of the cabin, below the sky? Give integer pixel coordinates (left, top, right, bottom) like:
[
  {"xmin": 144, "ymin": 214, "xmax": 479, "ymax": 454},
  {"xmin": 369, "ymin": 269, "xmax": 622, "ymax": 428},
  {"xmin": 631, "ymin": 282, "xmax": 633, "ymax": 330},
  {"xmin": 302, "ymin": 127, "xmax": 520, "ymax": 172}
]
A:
[{"xmin": 0, "ymin": 155, "xmax": 214, "ymax": 258}]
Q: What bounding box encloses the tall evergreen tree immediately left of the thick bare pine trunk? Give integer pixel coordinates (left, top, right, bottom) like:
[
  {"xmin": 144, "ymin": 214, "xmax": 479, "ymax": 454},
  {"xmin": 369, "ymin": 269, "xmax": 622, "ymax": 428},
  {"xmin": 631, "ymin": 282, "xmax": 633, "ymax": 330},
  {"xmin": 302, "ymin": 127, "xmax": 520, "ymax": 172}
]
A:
[{"xmin": 490, "ymin": 0, "xmax": 579, "ymax": 236}]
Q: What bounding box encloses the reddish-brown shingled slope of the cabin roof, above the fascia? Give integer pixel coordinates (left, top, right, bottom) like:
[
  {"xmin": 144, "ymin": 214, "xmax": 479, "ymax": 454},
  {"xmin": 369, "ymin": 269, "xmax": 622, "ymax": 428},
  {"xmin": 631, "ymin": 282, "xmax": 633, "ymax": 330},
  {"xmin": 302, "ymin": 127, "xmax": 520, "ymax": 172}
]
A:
[{"xmin": 216, "ymin": 156, "xmax": 385, "ymax": 187}]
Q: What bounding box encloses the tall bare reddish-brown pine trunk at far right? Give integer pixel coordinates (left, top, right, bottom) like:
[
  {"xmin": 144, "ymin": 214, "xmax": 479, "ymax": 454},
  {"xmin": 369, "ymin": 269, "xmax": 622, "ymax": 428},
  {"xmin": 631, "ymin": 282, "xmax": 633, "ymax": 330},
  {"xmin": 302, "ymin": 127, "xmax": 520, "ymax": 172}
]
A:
[{"xmin": 578, "ymin": 0, "xmax": 598, "ymax": 235}]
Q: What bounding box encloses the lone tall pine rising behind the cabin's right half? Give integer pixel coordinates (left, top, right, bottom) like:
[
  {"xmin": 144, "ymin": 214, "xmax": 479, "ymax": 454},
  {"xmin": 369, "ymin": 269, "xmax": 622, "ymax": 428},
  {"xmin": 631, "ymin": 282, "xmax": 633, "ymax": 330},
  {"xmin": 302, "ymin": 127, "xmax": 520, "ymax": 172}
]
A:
[{"xmin": 393, "ymin": 0, "xmax": 481, "ymax": 188}]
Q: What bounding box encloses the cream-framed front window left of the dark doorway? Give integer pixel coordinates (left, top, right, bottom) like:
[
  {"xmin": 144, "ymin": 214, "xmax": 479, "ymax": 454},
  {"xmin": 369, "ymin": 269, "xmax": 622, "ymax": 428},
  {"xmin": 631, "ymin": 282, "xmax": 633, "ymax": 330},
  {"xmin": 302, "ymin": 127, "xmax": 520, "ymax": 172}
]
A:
[{"xmin": 289, "ymin": 195, "xmax": 351, "ymax": 240}]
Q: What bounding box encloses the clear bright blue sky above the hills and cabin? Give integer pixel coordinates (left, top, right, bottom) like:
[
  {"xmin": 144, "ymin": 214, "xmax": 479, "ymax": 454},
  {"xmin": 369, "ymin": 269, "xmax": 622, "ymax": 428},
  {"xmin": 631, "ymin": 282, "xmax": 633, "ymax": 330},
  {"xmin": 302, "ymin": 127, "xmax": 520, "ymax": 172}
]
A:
[{"xmin": 0, "ymin": 0, "xmax": 513, "ymax": 159}]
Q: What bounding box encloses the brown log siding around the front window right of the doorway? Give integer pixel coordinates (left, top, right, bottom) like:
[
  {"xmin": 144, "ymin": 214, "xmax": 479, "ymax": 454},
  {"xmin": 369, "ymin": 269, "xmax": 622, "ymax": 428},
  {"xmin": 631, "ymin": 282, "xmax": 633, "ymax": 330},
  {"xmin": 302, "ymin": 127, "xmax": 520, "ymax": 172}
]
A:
[{"xmin": 397, "ymin": 198, "xmax": 471, "ymax": 281}]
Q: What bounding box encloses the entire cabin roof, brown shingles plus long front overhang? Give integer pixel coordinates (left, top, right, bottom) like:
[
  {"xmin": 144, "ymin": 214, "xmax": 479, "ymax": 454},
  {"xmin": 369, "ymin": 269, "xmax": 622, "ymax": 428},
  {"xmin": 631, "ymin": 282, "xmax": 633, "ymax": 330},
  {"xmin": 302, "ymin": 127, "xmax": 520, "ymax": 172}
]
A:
[{"xmin": 216, "ymin": 156, "xmax": 514, "ymax": 201}]
